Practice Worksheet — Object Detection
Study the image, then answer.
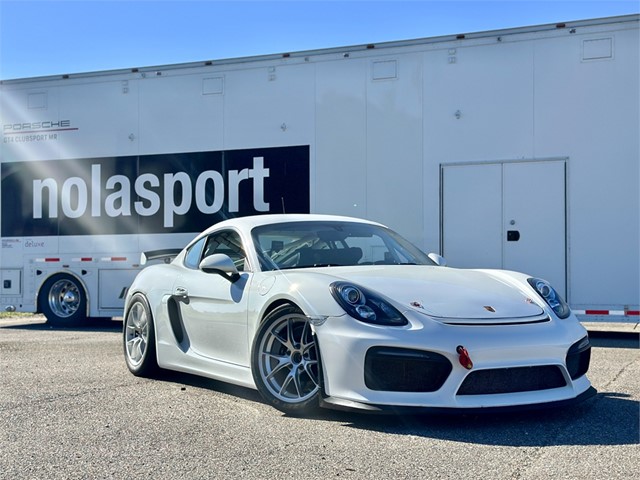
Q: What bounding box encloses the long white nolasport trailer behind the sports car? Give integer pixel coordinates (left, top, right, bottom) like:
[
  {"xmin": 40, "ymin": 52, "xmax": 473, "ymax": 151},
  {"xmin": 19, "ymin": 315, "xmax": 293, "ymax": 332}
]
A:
[{"xmin": 0, "ymin": 15, "xmax": 640, "ymax": 323}]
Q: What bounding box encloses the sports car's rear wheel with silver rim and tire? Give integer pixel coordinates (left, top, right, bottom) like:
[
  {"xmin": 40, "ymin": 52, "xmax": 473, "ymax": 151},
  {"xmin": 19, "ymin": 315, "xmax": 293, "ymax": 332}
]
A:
[{"xmin": 122, "ymin": 294, "xmax": 158, "ymax": 377}]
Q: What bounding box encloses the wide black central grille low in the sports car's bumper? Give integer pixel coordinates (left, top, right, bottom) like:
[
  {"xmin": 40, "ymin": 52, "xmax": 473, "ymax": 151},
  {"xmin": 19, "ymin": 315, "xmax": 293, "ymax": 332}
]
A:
[{"xmin": 458, "ymin": 365, "xmax": 567, "ymax": 395}]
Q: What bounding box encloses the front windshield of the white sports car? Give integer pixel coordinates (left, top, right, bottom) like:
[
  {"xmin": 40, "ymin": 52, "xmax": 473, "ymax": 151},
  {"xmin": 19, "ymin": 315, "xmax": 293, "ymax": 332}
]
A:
[{"xmin": 252, "ymin": 221, "xmax": 435, "ymax": 271}]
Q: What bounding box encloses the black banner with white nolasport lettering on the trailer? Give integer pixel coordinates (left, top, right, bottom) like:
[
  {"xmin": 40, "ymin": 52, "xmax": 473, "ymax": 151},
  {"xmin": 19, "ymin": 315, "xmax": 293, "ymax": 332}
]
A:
[{"xmin": 0, "ymin": 146, "xmax": 310, "ymax": 237}]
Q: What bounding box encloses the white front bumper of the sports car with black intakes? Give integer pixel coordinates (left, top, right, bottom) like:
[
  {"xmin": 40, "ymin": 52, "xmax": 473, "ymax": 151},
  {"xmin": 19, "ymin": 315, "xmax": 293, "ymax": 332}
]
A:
[{"xmin": 316, "ymin": 315, "xmax": 595, "ymax": 411}]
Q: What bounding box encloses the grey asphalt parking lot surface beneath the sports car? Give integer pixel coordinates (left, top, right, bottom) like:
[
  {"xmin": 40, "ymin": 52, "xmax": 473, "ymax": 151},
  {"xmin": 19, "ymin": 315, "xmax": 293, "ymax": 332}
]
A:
[{"xmin": 0, "ymin": 317, "xmax": 640, "ymax": 479}]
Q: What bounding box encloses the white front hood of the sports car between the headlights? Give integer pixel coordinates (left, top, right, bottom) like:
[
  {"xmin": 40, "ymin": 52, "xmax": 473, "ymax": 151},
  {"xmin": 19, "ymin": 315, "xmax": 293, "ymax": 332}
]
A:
[{"xmin": 331, "ymin": 265, "xmax": 544, "ymax": 320}]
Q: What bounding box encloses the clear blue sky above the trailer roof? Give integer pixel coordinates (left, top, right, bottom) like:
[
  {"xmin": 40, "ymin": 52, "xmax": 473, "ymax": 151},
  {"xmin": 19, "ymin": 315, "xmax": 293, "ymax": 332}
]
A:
[{"xmin": 0, "ymin": 0, "xmax": 640, "ymax": 80}]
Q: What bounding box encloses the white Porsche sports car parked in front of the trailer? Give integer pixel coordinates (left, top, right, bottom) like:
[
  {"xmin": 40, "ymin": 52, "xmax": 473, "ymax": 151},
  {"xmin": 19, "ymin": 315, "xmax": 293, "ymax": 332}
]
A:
[{"xmin": 123, "ymin": 215, "xmax": 596, "ymax": 414}]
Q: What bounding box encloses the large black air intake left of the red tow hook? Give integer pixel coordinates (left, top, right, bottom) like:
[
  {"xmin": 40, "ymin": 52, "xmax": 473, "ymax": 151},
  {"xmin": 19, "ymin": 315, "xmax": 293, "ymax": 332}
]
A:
[{"xmin": 364, "ymin": 347, "xmax": 453, "ymax": 392}]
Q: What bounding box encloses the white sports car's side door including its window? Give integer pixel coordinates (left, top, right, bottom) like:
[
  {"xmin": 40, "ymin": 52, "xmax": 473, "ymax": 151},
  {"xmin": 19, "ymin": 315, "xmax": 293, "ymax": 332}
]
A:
[{"xmin": 174, "ymin": 230, "xmax": 251, "ymax": 366}]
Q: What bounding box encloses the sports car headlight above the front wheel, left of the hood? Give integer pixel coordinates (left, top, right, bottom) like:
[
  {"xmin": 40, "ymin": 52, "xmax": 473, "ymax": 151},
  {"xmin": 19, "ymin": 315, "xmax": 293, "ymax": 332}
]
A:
[{"xmin": 330, "ymin": 282, "xmax": 409, "ymax": 327}]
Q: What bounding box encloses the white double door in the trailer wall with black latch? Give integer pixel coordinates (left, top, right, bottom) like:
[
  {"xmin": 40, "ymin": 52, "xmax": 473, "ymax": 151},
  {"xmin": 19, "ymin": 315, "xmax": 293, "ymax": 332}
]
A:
[{"xmin": 441, "ymin": 161, "xmax": 566, "ymax": 297}]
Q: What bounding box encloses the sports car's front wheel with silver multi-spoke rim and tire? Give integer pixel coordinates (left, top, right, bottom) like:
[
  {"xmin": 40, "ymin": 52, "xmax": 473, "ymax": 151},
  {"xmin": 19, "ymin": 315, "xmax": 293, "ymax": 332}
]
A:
[{"xmin": 251, "ymin": 305, "xmax": 321, "ymax": 415}]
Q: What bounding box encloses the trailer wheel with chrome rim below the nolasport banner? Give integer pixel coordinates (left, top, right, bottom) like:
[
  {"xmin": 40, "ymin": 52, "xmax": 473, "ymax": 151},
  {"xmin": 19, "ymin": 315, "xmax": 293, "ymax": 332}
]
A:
[{"xmin": 38, "ymin": 273, "xmax": 87, "ymax": 327}]
